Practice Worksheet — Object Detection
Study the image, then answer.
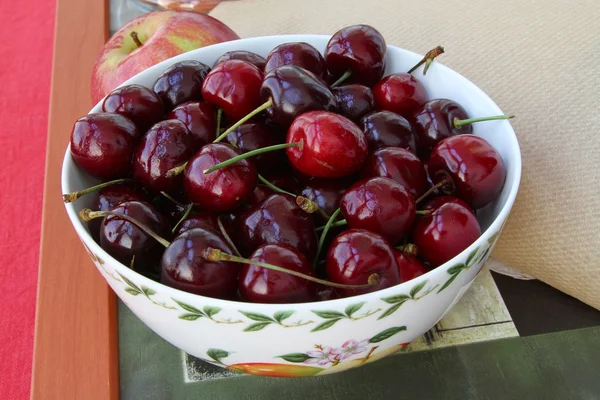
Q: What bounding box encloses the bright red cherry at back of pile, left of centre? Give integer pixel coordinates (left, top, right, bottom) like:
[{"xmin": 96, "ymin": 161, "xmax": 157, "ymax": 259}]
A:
[{"xmin": 202, "ymin": 60, "xmax": 263, "ymax": 120}]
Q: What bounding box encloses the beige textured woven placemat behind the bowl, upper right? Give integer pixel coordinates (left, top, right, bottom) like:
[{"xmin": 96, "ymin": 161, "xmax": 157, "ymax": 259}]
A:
[{"xmin": 211, "ymin": 0, "xmax": 600, "ymax": 309}]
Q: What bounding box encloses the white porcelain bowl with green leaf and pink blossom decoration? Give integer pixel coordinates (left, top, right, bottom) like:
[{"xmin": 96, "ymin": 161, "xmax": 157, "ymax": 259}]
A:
[{"xmin": 62, "ymin": 35, "xmax": 521, "ymax": 377}]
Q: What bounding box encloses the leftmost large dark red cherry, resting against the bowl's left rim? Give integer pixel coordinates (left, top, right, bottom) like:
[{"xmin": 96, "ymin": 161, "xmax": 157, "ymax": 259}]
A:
[{"xmin": 71, "ymin": 113, "xmax": 140, "ymax": 180}]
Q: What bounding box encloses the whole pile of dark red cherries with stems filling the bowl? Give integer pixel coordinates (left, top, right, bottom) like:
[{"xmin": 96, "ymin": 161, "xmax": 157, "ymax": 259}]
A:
[{"xmin": 64, "ymin": 25, "xmax": 509, "ymax": 303}]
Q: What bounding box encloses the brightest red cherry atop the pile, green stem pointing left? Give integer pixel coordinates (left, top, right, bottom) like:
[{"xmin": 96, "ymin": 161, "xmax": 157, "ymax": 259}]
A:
[{"xmin": 286, "ymin": 111, "xmax": 367, "ymax": 178}]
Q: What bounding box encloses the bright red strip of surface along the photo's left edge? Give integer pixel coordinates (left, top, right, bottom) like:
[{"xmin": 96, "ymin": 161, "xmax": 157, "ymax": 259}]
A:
[{"xmin": 0, "ymin": 0, "xmax": 56, "ymax": 399}]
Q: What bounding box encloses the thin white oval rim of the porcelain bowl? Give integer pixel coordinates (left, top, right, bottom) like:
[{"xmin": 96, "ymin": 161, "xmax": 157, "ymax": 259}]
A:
[{"xmin": 61, "ymin": 34, "xmax": 522, "ymax": 312}]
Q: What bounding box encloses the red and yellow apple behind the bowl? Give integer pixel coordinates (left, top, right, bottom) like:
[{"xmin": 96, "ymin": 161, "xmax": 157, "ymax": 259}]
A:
[{"xmin": 92, "ymin": 11, "xmax": 239, "ymax": 103}]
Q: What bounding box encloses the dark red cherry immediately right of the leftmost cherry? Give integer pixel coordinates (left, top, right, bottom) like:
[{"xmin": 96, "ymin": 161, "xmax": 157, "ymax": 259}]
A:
[{"xmin": 132, "ymin": 119, "xmax": 194, "ymax": 192}]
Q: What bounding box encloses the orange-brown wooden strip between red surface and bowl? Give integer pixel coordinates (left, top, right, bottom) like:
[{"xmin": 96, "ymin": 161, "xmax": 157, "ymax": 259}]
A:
[{"xmin": 31, "ymin": 0, "xmax": 119, "ymax": 400}]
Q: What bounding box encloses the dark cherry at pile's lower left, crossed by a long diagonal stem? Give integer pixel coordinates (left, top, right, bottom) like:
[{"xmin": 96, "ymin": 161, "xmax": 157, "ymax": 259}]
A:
[{"xmin": 100, "ymin": 201, "xmax": 171, "ymax": 271}]
